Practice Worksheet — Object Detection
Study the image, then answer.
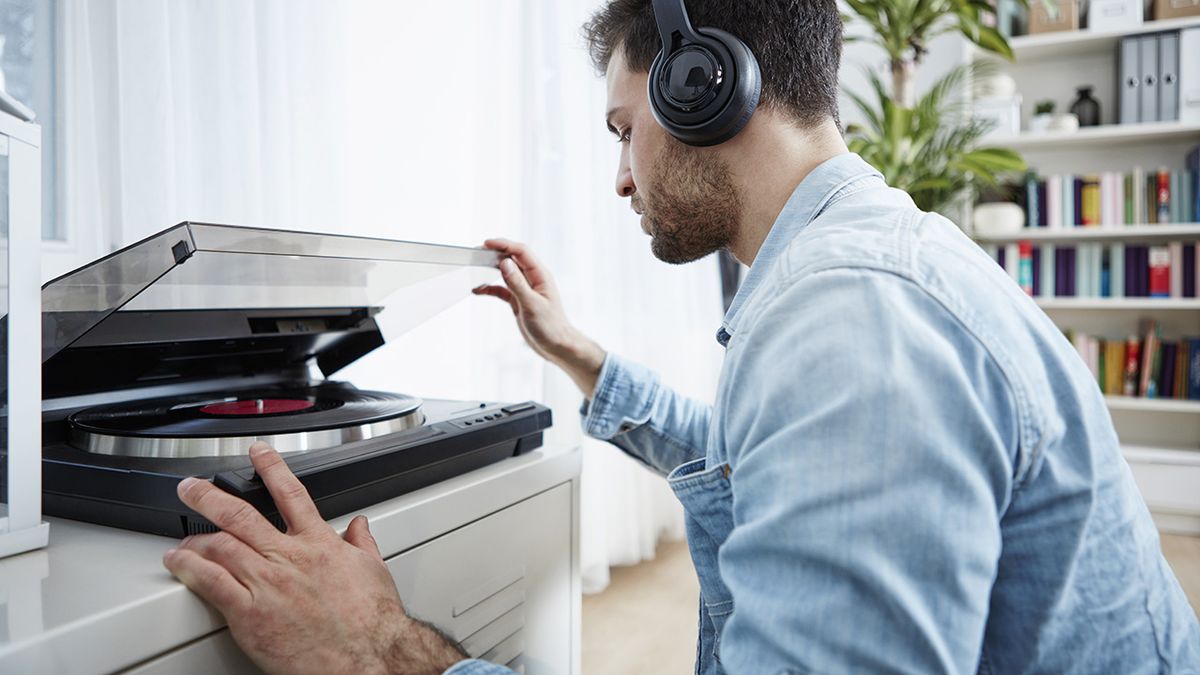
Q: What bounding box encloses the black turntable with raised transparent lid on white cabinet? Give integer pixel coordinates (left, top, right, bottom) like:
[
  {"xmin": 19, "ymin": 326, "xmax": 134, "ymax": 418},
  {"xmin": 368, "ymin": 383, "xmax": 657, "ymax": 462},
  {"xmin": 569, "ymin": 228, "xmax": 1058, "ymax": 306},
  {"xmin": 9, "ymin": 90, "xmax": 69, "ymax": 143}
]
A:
[{"xmin": 8, "ymin": 223, "xmax": 551, "ymax": 537}]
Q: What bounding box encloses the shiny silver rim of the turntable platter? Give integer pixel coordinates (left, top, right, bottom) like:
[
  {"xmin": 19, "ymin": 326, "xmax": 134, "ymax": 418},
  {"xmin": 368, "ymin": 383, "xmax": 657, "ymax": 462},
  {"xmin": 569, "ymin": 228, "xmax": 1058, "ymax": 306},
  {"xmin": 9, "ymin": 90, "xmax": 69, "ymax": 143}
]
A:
[{"xmin": 71, "ymin": 399, "xmax": 425, "ymax": 459}]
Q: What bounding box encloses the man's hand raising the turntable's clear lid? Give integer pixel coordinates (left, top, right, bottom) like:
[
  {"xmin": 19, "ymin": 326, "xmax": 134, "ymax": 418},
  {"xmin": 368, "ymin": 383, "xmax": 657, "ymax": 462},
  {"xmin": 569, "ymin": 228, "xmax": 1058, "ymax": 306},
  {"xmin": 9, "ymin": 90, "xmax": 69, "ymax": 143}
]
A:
[{"xmin": 472, "ymin": 239, "xmax": 605, "ymax": 399}]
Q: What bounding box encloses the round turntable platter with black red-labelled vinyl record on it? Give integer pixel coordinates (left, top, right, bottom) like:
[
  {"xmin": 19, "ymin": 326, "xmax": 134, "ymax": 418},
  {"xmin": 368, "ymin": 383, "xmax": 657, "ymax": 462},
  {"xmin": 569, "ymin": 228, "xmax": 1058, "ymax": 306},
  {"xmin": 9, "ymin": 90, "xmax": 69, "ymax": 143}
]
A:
[{"xmin": 67, "ymin": 383, "xmax": 425, "ymax": 459}]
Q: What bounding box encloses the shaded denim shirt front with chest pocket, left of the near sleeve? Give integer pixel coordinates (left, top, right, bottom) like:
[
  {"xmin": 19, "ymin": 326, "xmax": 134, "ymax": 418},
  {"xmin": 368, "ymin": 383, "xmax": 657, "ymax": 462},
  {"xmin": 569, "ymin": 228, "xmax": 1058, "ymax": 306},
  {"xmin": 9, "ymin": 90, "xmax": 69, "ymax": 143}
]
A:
[{"xmin": 667, "ymin": 460, "xmax": 733, "ymax": 673}]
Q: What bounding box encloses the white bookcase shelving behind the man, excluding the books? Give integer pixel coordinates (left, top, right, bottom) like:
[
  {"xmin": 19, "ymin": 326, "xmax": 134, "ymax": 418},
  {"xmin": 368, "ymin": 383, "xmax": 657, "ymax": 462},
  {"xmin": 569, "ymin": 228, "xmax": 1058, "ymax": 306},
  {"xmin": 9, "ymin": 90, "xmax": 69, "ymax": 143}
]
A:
[{"xmin": 966, "ymin": 17, "xmax": 1200, "ymax": 533}]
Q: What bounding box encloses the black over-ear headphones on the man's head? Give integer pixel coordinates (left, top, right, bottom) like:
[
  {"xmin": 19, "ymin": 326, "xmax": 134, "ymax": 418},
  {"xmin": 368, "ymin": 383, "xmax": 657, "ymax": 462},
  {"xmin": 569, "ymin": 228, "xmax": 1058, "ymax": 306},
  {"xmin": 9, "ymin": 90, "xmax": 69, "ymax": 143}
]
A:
[{"xmin": 649, "ymin": 0, "xmax": 762, "ymax": 147}]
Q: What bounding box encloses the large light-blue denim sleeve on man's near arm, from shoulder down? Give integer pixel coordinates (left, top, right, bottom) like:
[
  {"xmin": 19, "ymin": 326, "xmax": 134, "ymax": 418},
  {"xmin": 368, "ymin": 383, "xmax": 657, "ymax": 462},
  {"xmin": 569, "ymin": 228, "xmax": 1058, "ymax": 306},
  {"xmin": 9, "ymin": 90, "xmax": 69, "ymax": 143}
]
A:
[{"xmin": 719, "ymin": 269, "xmax": 1016, "ymax": 673}]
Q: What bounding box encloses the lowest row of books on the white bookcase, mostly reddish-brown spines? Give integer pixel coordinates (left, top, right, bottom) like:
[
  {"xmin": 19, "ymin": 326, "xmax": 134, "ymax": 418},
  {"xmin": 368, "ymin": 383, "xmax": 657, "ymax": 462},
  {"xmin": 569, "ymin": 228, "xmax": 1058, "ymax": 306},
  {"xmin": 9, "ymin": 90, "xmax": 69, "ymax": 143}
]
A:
[{"xmin": 1067, "ymin": 322, "xmax": 1200, "ymax": 401}]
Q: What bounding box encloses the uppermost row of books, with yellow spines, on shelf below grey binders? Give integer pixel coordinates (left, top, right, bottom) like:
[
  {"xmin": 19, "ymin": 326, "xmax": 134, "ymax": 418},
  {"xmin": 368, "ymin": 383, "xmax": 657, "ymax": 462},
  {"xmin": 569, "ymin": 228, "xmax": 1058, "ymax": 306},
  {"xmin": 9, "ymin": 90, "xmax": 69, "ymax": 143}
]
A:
[{"xmin": 1018, "ymin": 147, "xmax": 1200, "ymax": 229}]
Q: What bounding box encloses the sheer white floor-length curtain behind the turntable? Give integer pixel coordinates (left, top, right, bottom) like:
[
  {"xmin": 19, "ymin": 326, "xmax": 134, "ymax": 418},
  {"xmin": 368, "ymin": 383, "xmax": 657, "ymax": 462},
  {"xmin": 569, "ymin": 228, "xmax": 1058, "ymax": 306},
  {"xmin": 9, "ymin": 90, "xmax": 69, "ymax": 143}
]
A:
[{"xmin": 60, "ymin": 0, "xmax": 721, "ymax": 591}]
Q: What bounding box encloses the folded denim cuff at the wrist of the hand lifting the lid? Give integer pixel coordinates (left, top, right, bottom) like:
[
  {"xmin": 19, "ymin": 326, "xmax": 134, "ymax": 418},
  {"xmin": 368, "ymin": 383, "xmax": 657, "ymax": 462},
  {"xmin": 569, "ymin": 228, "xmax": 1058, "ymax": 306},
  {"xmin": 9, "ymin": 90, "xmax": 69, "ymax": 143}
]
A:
[{"xmin": 580, "ymin": 353, "xmax": 659, "ymax": 441}]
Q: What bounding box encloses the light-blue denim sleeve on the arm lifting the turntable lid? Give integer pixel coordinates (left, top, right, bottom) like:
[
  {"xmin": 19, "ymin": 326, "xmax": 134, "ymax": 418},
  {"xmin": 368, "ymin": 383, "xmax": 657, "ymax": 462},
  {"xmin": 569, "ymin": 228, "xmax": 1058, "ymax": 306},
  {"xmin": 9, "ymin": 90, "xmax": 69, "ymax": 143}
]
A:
[{"xmin": 580, "ymin": 354, "xmax": 713, "ymax": 476}]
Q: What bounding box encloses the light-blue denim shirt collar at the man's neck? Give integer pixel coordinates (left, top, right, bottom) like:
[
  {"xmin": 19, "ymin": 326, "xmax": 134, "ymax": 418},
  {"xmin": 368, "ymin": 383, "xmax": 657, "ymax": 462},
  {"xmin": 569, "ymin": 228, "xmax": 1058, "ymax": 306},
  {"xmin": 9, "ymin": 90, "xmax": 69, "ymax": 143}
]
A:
[{"xmin": 716, "ymin": 153, "xmax": 883, "ymax": 347}]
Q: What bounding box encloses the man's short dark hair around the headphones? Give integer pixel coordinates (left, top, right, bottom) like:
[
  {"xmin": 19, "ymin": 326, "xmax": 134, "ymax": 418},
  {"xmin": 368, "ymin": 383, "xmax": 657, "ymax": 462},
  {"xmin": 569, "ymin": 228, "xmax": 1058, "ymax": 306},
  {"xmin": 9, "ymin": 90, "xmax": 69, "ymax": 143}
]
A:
[{"xmin": 583, "ymin": 0, "xmax": 841, "ymax": 126}]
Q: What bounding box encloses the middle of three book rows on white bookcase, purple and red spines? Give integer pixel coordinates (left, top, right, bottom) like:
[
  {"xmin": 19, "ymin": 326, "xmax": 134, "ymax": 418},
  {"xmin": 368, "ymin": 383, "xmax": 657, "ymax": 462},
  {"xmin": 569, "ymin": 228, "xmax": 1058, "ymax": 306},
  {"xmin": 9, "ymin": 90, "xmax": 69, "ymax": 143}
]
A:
[{"xmin": 984, "ymin": 241, "xmax": 1200, "ymax": 298}]
